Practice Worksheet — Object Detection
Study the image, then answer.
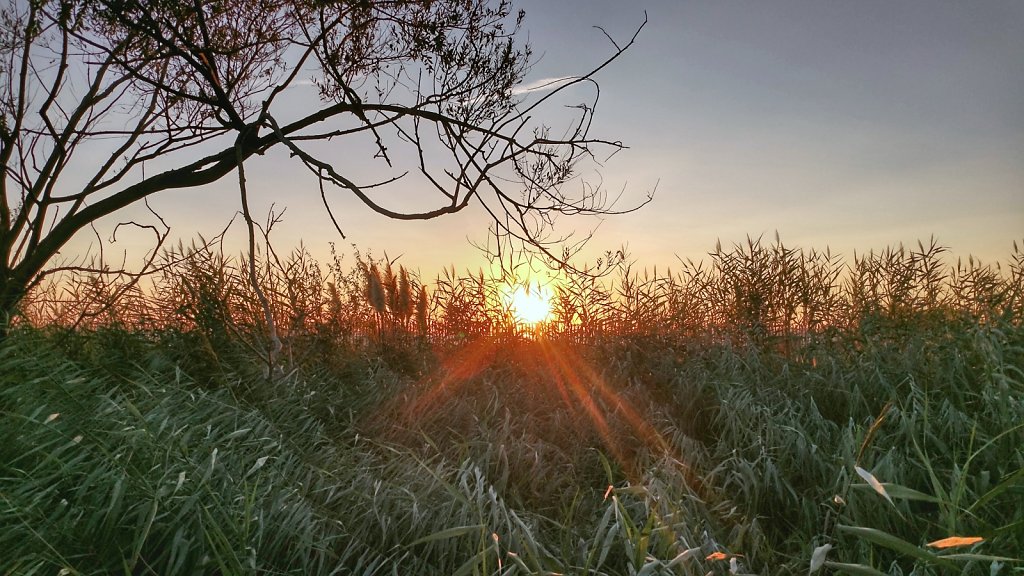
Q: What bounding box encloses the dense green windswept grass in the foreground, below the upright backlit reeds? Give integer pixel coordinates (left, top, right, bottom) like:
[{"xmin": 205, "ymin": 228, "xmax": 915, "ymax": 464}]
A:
[{"xmin": 0, "ymin": 313, "xmax": 1024, "ymax": 575}]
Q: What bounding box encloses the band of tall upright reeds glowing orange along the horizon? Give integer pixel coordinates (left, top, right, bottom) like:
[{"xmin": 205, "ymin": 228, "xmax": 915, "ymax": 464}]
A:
[{"xmin": 22, "ymin": 231, "xmax": 1024, "ymax": 355}]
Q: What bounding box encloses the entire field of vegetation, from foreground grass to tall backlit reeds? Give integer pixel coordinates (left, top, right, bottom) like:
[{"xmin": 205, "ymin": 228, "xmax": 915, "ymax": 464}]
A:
[{"xmin": 0, "ymin": 238, "xmax": 1024, "ymax": 576}]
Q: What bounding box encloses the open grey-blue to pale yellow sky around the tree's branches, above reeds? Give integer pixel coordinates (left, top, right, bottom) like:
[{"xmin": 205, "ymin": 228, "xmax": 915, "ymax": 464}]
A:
[{"xmin": 81, "ymin": 0, "xmax": 1024, "ymax": 276}]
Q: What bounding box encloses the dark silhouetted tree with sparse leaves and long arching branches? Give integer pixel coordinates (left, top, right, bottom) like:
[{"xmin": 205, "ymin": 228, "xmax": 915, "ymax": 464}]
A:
[{"xmin": 0, "ymin": 0, "xmax": 646, "ymax": 334}]
